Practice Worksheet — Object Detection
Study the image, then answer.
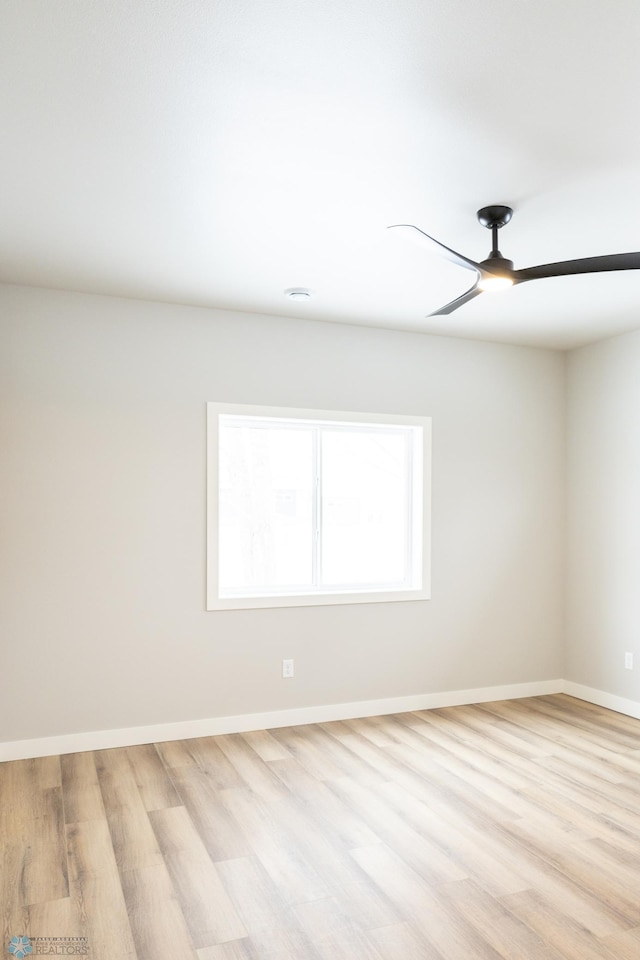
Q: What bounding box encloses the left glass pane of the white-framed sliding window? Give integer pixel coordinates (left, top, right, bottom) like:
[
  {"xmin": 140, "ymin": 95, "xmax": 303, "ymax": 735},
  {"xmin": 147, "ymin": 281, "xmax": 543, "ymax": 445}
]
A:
[{"xmin": 218, "ymin": 422, "xmax": 313, "ymax": 594}]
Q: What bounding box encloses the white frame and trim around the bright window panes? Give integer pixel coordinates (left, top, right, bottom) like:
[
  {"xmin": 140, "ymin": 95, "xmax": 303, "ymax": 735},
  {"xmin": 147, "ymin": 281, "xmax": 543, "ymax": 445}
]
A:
[{"xmin": 207, "ymin": 402, "xmax": 431, "ymax": 610}]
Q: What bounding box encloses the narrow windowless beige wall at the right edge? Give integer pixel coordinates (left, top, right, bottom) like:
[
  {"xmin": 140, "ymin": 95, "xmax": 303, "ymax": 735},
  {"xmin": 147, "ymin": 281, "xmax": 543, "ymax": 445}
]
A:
[{"xmin": 565, "ymin": 333, "xmax": 640, "ymax": 702}]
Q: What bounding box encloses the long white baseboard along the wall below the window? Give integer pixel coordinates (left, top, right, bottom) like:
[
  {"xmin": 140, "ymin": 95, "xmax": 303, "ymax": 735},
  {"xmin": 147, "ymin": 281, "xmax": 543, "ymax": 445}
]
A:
[{"xmin": 0, "ymin": 680, "xmax": 564, "ymax": 762}]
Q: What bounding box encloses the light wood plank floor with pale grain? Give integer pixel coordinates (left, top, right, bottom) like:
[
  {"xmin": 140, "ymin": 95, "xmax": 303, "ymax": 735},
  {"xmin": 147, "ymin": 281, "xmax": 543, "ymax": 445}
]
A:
[{"xmin": 0, "ymin": 696, "xmax": 640, "ymax": 960}]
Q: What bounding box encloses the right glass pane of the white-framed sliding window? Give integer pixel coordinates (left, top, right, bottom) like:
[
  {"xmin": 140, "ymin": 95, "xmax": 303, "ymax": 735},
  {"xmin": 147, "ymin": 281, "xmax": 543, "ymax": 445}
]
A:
[{"xmin": 321, "ymin": 429, "xmax": 409, "ymax": 587}]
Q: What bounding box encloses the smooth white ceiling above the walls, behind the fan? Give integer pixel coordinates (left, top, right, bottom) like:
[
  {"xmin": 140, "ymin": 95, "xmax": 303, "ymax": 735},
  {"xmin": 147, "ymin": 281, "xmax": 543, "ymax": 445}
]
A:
[{"xmin": 0, "ymin": 0, "xmax": 640, "ymax": 348}]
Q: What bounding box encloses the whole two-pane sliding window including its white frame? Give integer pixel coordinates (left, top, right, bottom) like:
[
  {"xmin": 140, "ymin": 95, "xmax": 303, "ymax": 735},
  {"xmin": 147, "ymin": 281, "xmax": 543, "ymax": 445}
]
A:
[{"xmin": 207, "ymin": 403, "xmax": 431, "ymax": 610}]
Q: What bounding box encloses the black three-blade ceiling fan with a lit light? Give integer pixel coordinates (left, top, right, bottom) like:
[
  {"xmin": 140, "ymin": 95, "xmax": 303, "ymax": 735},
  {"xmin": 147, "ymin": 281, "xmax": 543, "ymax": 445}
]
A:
[{"xmin": 389, "ymin": 204, "xmax": 640, "ymax": 317}]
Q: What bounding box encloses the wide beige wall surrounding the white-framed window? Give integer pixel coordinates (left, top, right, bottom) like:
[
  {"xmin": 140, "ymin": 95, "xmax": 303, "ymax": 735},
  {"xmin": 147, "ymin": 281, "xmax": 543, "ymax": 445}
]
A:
[{"xmin": 0, "ymin": 286, "xmax": 565, "ymax": 741}]
